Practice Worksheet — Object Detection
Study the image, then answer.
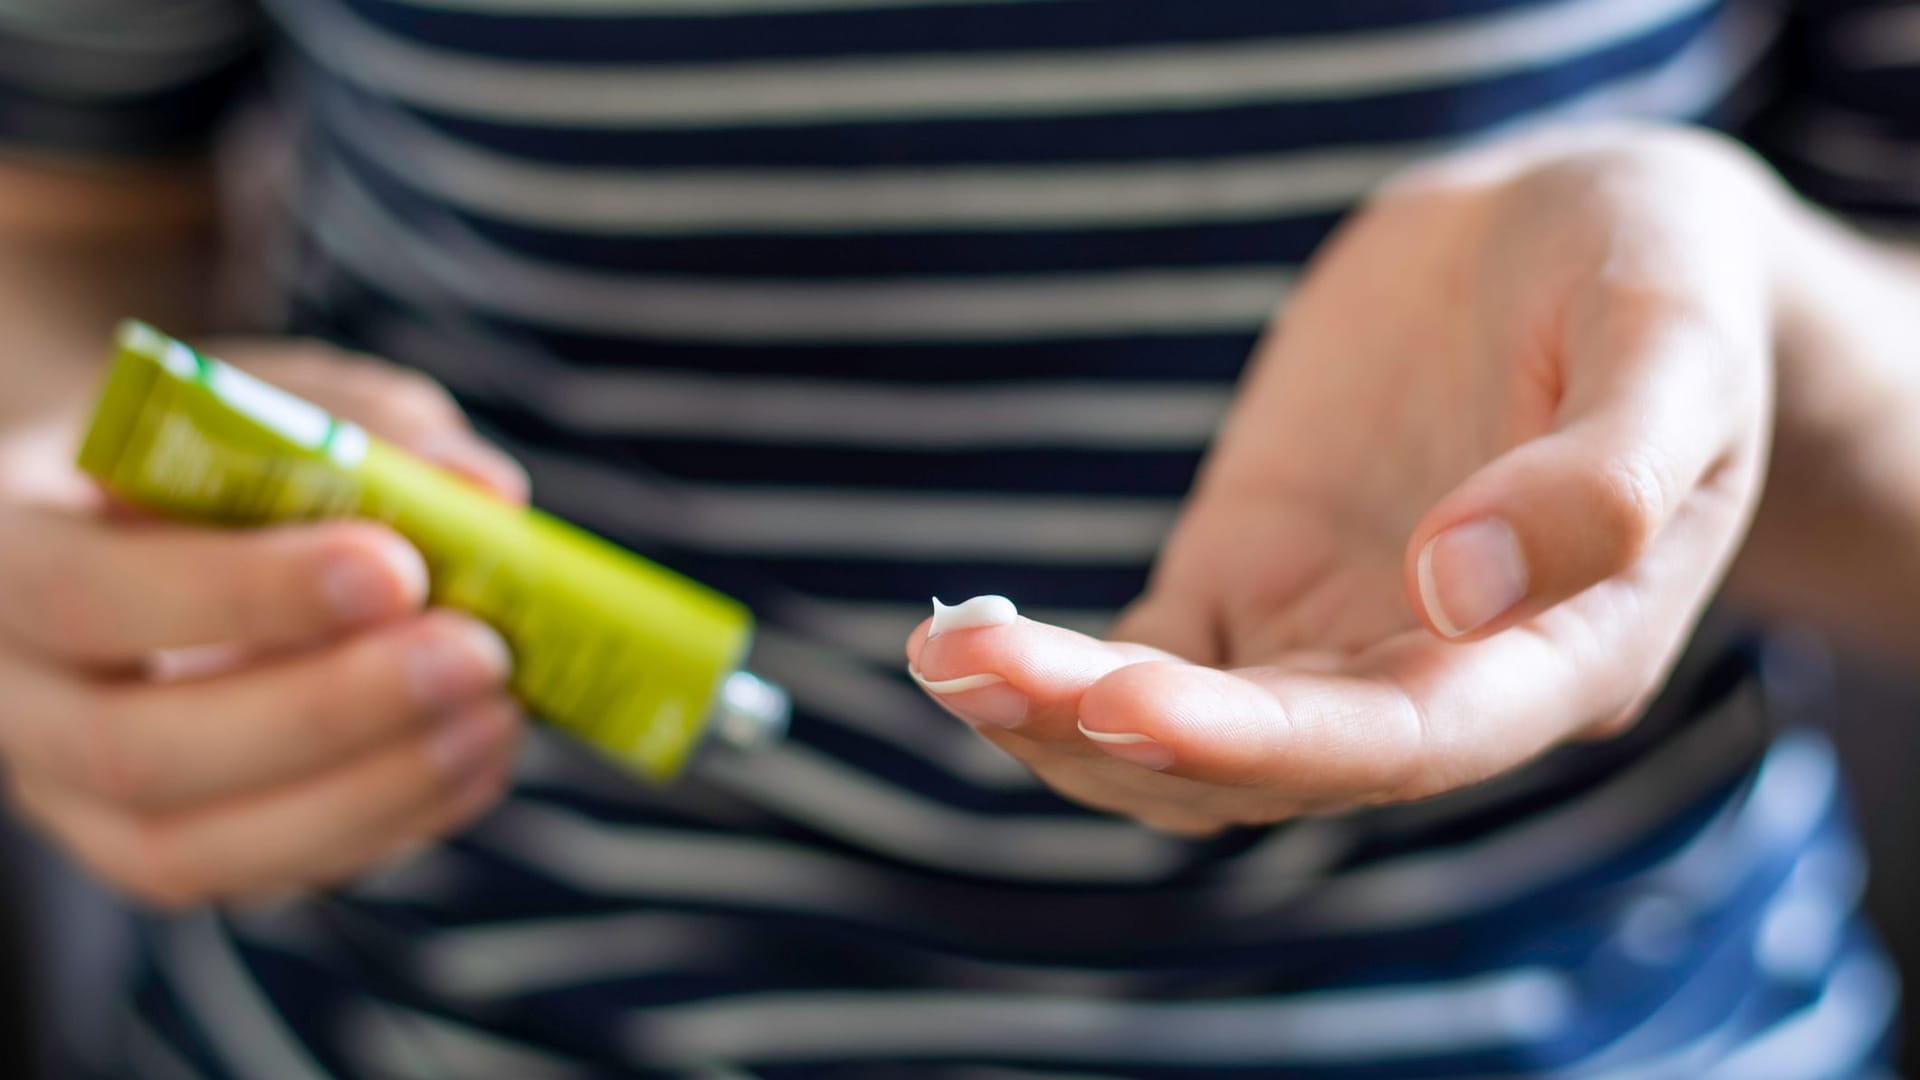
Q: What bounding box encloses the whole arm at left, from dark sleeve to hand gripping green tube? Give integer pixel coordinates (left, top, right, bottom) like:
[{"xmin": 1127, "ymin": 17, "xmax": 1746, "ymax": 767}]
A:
[{"xmin": 0, "ymin": 14, "xmax": 524, "ymax": 903}]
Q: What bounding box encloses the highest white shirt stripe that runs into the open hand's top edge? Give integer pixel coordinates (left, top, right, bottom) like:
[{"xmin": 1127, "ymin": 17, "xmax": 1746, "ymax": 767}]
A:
[{"xmin": 321, "ymin": 87, "xmax": 1450, "ymax": 236}]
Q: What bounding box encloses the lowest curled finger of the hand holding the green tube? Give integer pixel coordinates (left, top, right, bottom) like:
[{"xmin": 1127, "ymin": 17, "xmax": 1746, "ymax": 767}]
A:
[{"xmin": 17, "ymin": 701, "xmax": 520, "ymax": 907}]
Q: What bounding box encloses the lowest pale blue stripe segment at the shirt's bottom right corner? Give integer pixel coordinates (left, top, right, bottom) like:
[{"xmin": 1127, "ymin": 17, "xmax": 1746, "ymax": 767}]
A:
[{"xmin": 1701, "ymin": 947, "xmax": 1899, "ymax": 1080}]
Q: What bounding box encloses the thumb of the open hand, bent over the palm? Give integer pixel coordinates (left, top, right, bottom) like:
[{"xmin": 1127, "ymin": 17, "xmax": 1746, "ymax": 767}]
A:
[{"xmin": 1404, "ymin": 292, "xmax": 1761, "ymax": 638}]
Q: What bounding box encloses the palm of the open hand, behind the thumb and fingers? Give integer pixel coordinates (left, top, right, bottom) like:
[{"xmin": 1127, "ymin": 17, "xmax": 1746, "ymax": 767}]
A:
[{"xmin": 1156, "ymin": 177, "xmax": 1555, "ymax": 667}]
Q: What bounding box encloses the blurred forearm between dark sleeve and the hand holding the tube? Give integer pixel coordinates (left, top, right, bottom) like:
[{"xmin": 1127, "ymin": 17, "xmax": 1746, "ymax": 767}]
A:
[{"xmin": 0, "ymin": 160, "xmax": 213, "ymax": 427}]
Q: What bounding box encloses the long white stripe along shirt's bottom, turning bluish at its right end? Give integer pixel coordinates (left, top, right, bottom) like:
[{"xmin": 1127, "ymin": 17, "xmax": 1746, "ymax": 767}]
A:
[{"xmin": 624, "ymin": 969, "xmax": 1572, "ymax": 1065}]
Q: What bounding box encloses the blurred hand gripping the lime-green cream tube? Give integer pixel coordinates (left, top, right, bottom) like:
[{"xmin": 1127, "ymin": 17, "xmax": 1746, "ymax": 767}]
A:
[{"xmin": 0, "ymin": 334, "xmax": 526, "ymax": 907}]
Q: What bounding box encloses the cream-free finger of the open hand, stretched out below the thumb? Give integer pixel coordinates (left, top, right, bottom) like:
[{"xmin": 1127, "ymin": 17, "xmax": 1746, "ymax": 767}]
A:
[{"xmin": 1079, "ymin": 476, "xmax": 1740, "ymax": 791}]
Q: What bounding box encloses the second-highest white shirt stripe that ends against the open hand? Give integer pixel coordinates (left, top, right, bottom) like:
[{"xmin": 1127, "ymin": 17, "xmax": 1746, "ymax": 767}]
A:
[{"xmin": 313, "ymin": 169, "xmax": 1294, "ymax": 344}]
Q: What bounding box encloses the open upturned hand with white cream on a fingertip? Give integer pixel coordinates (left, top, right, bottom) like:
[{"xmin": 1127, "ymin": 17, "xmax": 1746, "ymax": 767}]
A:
[{"xmin": 906, "ymin": 129, "xmax": 1780, "ymax": 834}]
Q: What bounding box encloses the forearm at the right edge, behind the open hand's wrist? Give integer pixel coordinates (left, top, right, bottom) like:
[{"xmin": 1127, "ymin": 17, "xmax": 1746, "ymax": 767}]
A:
[{"xmin": 1728, "ymin": 204, "xmax": 1920, "ymax": 667}]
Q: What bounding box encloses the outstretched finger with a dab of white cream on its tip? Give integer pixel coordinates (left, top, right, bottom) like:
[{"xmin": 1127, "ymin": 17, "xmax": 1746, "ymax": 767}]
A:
[{"xmin": 908, "ymin": 596, "xmax": 1169, "ymax": 742}]
